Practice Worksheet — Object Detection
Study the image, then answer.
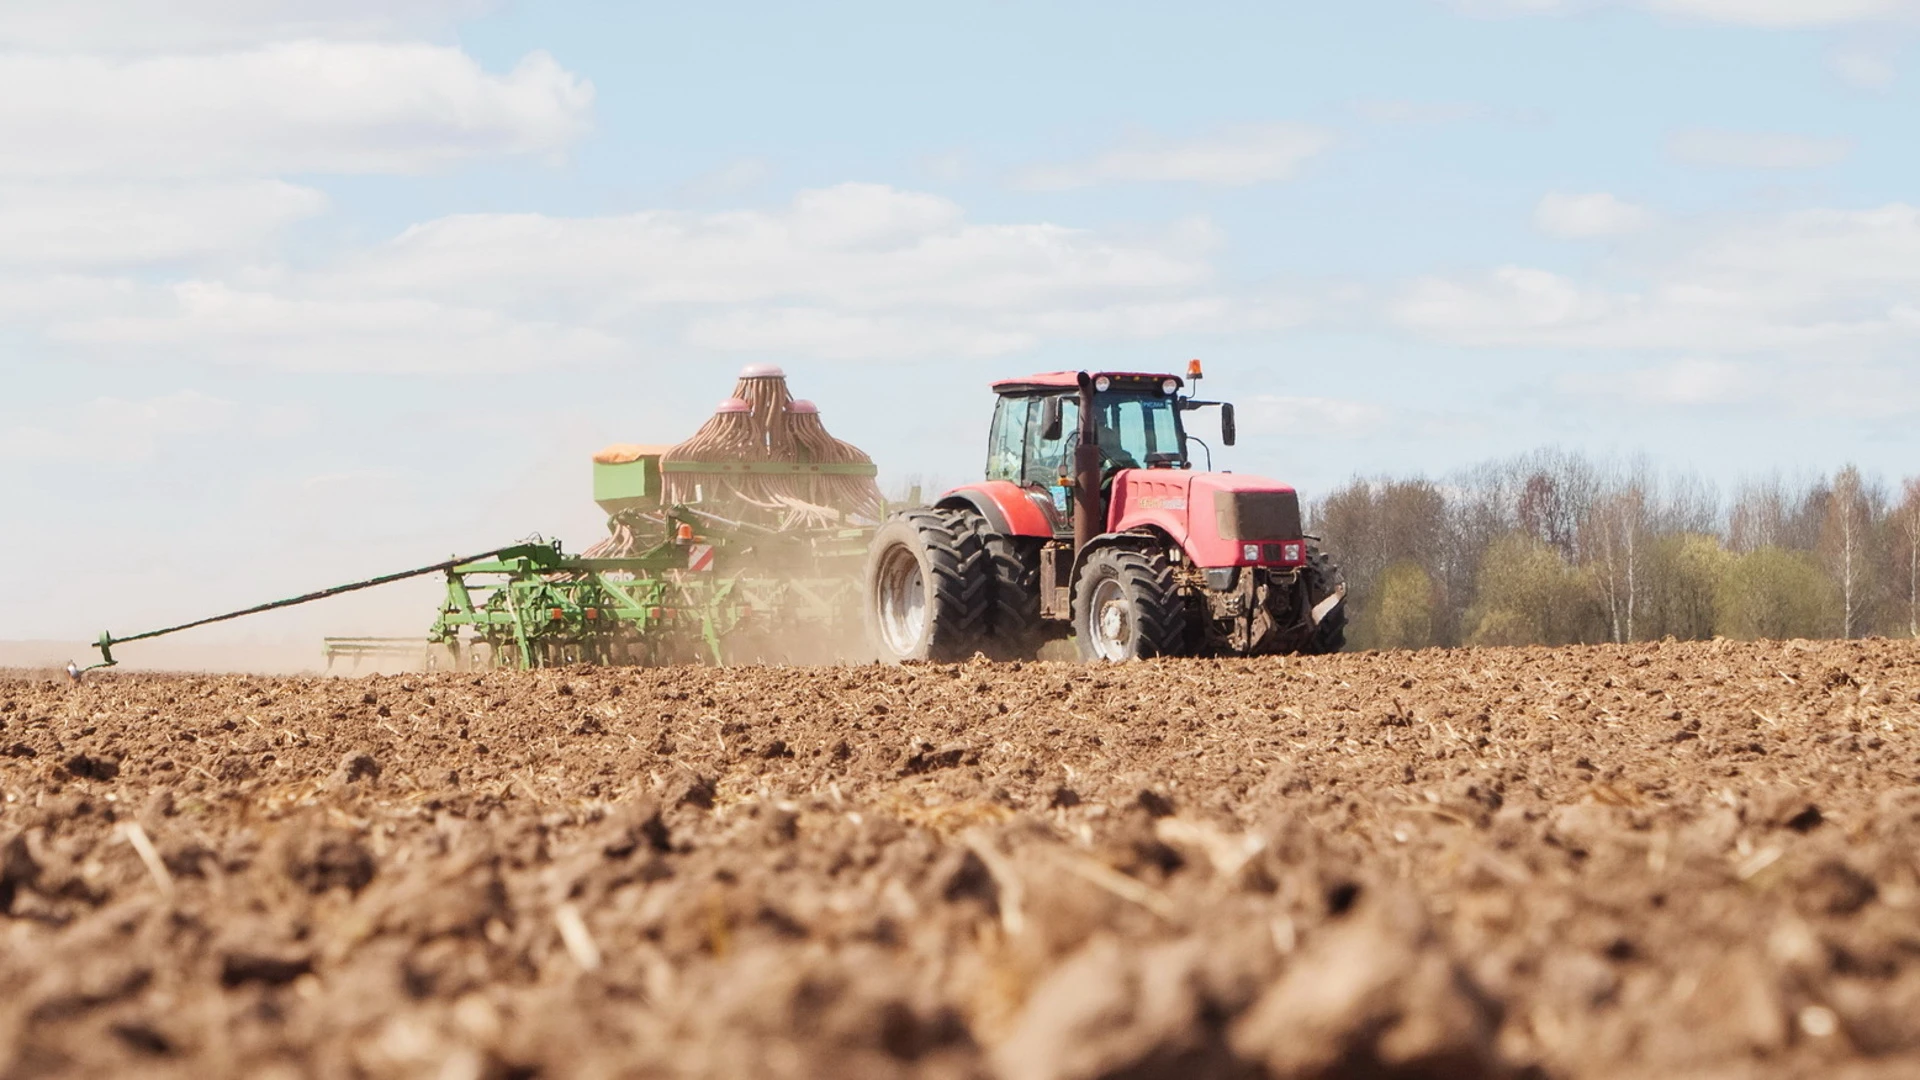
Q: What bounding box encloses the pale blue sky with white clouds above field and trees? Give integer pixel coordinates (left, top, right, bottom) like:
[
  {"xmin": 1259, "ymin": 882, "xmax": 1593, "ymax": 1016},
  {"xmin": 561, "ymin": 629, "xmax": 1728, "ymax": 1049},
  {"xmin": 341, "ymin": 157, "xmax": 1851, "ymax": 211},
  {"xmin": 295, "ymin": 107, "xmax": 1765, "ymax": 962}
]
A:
[{"xmin": 0, "ymin": 0, "xmax": 1920, "ymax": 638}]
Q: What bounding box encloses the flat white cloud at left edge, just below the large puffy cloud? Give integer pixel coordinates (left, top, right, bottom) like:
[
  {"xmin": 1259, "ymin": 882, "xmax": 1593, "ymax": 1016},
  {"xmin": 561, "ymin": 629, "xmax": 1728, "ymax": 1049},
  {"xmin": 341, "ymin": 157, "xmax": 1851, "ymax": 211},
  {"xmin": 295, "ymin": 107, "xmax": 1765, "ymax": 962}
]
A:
[{"xmin": 0, "ymin": 181, "xmax": 328, "ymax": 271}]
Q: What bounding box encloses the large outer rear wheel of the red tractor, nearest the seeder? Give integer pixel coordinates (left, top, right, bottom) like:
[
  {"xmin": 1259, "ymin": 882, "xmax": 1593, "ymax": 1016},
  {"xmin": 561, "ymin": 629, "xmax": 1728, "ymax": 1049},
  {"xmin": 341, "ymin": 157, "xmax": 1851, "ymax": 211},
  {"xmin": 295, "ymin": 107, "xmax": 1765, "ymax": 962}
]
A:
[{"xmin": 862, "ymin": 509, "xmax": 993, "ymax": 663}]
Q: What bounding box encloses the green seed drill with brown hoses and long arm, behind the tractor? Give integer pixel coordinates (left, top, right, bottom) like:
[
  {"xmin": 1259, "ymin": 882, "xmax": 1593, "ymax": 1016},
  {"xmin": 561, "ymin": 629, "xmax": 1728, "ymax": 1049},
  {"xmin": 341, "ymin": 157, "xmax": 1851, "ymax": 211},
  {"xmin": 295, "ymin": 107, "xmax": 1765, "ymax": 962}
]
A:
[{"xmin": 82, "ymin": 365, "xmax": 883, "ymax": 671}]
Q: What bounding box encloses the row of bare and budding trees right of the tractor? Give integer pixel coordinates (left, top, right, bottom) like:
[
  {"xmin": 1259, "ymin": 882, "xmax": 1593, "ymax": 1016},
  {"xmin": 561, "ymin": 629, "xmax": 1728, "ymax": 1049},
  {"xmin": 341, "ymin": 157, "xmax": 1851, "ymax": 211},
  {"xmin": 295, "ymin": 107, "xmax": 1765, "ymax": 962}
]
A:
[{"xmin": 1308, "ymin": 450, "xmax": 1920, "ymax": 648}]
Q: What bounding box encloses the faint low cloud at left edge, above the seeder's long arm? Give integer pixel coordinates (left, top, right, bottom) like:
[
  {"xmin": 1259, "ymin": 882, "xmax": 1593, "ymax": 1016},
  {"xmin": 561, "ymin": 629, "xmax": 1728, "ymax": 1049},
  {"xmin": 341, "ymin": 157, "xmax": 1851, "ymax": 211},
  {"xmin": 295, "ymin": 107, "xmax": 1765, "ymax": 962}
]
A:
[{"xmin": 0, "ymin": 390, "xmax": 238, "ymax": 461}]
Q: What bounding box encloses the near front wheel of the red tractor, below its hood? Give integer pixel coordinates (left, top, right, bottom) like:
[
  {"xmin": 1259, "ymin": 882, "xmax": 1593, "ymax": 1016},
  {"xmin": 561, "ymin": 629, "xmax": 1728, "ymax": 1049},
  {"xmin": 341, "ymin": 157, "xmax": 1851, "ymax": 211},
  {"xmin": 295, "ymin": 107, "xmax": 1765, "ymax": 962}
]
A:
[{"xmin": 1073, "ymin": 548, "xmax": 1187, "ymax": 663}]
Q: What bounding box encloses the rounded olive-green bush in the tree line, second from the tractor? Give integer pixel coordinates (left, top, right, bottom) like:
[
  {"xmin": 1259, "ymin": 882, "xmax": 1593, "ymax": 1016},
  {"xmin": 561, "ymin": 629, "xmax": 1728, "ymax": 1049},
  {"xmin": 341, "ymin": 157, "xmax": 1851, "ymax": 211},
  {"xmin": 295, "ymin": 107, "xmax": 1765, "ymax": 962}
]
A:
[{"xmin": 1467, "ymin": 532, "xmax": 1605, "ymax": 646}]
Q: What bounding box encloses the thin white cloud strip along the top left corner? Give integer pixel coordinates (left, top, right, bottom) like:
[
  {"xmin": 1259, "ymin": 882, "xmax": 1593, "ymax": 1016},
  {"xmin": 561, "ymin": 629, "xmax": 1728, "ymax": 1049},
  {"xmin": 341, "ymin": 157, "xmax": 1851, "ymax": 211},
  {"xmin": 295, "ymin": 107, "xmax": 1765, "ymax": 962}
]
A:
[{"xmin": 0, "ymin": 0, "xmax": 497, "ymax": 52}]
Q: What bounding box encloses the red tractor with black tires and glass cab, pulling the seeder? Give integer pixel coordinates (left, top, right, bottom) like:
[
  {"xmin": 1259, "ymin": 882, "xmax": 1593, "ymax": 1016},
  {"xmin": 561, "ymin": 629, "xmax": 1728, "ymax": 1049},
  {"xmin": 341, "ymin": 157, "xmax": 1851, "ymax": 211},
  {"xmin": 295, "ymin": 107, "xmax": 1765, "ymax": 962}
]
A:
[{"xmin": 866, "ymin": 361, "xmax": 1346, "ymax": 661}]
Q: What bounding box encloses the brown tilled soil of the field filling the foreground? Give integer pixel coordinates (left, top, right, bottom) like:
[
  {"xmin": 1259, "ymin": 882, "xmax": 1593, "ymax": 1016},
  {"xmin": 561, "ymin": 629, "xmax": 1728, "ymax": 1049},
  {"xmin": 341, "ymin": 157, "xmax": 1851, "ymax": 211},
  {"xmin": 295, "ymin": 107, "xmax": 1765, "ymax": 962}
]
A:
[{"xmin": 0, "ymin": 642, "xmax": 1920, "ymax": 1080}]
